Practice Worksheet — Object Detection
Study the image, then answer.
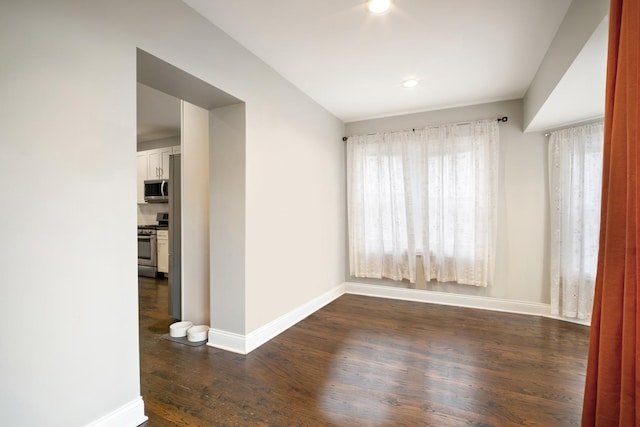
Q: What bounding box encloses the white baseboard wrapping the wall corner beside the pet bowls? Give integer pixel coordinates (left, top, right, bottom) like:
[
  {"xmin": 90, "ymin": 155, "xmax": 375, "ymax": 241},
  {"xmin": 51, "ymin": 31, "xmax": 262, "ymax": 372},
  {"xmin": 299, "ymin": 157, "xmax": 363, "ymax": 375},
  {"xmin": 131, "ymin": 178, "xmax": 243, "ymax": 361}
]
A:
[{"xmin": 207, "ymin": 284, "xmax": 344, "ymax": 354}]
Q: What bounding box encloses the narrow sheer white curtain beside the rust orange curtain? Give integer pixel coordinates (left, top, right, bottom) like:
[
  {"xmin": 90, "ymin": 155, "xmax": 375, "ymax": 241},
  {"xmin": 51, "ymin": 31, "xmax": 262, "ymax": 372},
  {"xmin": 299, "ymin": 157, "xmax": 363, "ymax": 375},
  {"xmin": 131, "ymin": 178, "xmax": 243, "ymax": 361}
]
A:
[{"xmin": 549, "ymin": 123, "xmax": 604, "ymax": 321}]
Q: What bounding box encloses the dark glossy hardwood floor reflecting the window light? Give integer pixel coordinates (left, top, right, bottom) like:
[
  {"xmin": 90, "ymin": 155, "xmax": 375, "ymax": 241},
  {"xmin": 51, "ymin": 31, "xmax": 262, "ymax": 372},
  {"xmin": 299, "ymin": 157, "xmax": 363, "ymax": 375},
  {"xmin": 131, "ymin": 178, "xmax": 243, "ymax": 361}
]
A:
[{"xmin": 139, "ymin": 278, "xmax": 588, "ymax": 427}]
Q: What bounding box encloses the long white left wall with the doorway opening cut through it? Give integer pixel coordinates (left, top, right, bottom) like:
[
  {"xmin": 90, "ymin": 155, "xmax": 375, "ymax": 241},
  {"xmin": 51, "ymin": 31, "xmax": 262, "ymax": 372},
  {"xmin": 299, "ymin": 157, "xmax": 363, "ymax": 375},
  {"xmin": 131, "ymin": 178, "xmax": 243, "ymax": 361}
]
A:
[{"xmin": 0, "ymin": 0, "xmax": 345, "ymax": 427}]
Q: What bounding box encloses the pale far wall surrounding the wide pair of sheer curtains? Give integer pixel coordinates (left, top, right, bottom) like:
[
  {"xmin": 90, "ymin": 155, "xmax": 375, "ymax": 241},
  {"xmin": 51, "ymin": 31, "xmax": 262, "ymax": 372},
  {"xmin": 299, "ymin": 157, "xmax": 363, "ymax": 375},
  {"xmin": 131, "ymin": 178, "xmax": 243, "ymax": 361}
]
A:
[{"xmin": 346, "ymin": 100, "xmax": 549, "ymax": 303}]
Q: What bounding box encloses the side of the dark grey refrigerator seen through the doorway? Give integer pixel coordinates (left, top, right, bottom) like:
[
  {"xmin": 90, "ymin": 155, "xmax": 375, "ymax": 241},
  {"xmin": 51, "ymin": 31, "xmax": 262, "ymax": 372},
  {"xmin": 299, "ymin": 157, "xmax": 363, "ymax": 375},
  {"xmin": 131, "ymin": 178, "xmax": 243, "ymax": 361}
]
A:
[{"xmin": 169, "ymin": 154, "xmax": 182, "ymax": 320}]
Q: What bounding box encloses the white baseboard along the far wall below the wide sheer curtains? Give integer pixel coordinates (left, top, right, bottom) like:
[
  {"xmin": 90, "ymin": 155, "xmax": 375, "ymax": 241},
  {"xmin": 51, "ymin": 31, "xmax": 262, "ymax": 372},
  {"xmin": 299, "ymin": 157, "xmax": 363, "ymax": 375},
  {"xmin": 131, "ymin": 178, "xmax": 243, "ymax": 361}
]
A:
[{"xmin": 344, "ymin": 282, "xmax": 550, "ymax": 316}]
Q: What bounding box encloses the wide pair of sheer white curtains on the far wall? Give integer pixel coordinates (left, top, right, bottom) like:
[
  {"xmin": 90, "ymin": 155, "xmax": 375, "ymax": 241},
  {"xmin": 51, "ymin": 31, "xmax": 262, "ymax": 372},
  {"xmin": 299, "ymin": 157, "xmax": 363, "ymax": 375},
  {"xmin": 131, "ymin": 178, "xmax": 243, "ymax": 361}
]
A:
[{"xmin": 347, "ymin": 120, "xmax": 499, "ymax": 286}]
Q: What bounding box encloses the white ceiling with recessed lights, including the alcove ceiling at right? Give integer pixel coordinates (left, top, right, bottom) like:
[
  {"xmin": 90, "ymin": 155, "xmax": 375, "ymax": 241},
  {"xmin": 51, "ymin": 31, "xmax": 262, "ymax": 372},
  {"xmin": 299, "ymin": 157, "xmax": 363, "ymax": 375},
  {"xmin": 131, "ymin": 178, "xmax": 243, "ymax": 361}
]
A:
[{"xmin": 139, "ymin": 0, "xmax": 607, "ymax": 140}]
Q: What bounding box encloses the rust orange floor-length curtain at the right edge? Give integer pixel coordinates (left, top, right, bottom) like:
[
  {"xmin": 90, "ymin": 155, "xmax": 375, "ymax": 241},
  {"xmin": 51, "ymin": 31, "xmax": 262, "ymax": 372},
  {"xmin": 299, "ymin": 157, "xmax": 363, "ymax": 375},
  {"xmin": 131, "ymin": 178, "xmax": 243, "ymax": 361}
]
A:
[{"xmin": 582, "ymin": 0, "xmax": 640, "ymax": 427}]
